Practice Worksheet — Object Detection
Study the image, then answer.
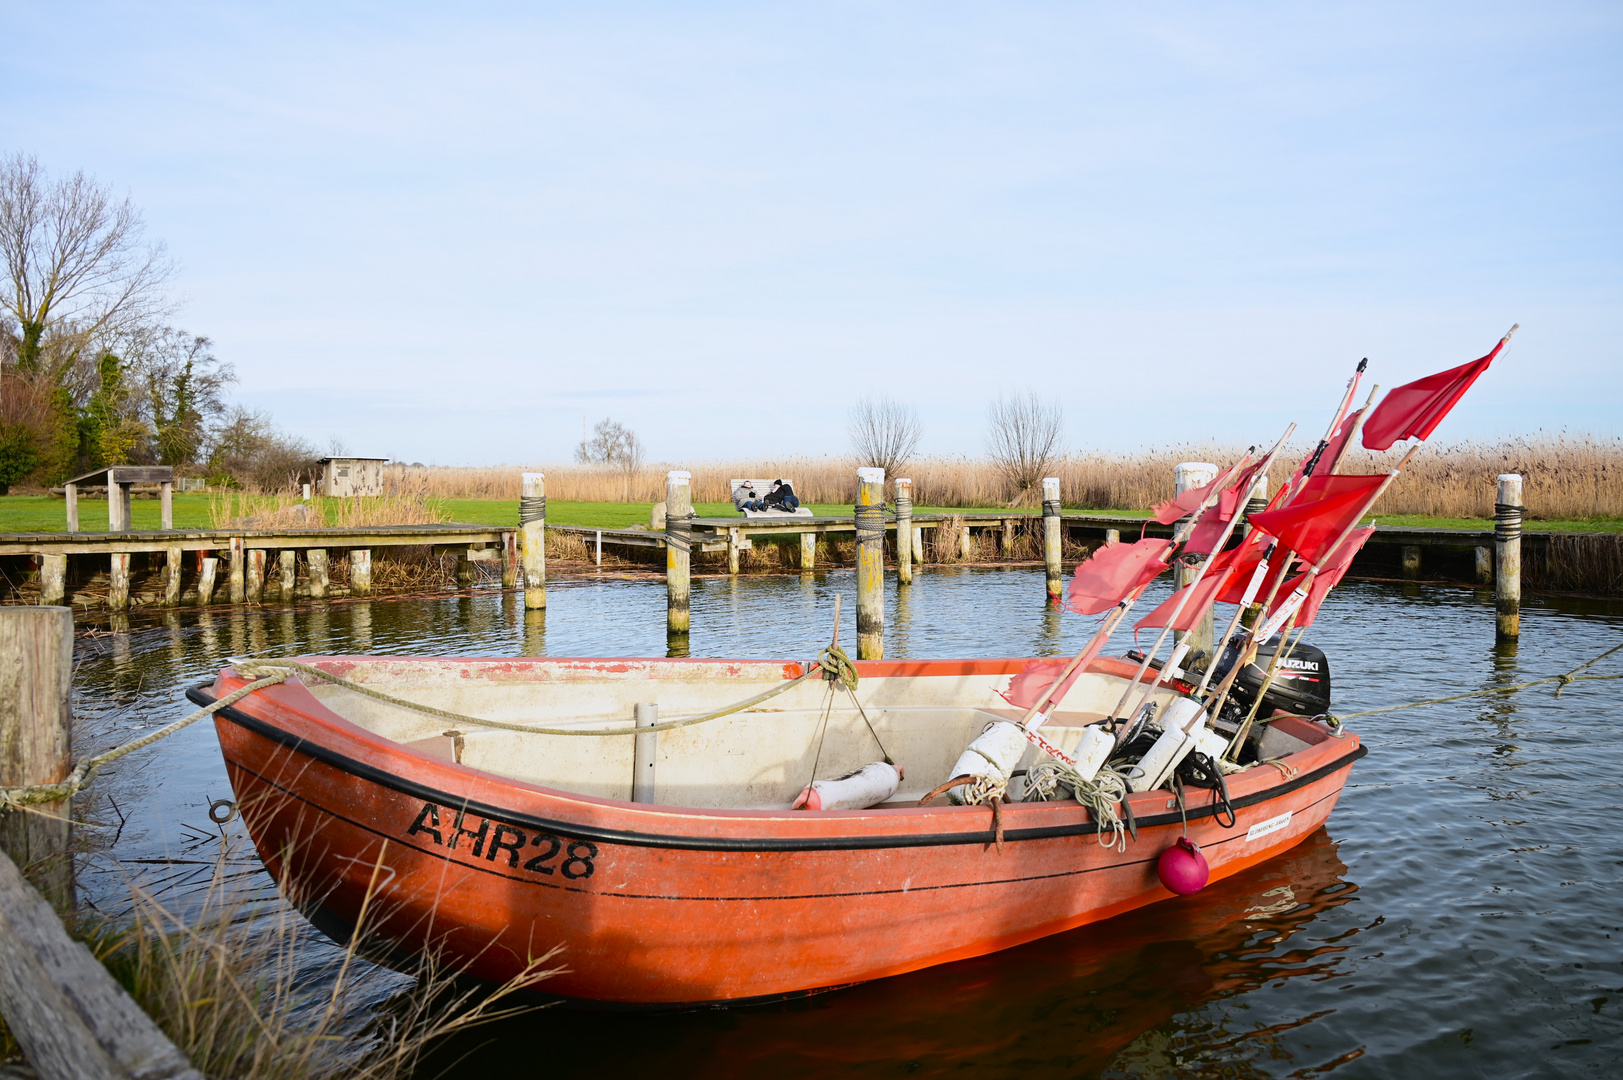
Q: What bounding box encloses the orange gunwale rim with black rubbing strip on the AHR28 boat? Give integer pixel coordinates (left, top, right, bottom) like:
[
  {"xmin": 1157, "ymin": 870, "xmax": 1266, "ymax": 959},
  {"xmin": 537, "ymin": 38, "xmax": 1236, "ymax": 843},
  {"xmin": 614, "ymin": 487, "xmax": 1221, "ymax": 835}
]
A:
[{"xmin": 187, "ymin": 658, "xmax": 1368, "ymax": 853}]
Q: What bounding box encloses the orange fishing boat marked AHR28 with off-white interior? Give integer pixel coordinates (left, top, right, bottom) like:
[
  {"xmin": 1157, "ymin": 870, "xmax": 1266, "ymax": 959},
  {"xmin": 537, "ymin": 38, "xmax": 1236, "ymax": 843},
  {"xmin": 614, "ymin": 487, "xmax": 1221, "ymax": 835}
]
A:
[{"xmin": 190, "ymin": 656, "xmax": 1365, "ymax": 1007}]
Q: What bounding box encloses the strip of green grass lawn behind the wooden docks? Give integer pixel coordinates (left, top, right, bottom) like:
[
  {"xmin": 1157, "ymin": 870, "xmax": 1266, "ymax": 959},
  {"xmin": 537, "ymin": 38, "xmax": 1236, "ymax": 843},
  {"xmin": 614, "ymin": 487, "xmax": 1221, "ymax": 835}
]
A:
[{"xmin": 9, "ymin": 492, "xmax": 1623, "ymax": 533}]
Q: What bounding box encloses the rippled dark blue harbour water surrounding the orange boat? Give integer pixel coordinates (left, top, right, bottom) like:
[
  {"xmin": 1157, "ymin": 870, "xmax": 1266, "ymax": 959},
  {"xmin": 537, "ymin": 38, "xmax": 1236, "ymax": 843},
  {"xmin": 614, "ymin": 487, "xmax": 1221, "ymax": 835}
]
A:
[{"xmin": 60, "ymin": 570, "xmax": 1623, "ymax": 1078}]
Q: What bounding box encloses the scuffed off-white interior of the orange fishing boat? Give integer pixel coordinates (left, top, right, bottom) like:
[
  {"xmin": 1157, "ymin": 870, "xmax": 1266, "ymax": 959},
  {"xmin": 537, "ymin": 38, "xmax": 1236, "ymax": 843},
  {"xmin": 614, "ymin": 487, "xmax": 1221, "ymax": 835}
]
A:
[{"xmin": 292, "ymin": 658, "xmax": 1194, "ymax": 809}]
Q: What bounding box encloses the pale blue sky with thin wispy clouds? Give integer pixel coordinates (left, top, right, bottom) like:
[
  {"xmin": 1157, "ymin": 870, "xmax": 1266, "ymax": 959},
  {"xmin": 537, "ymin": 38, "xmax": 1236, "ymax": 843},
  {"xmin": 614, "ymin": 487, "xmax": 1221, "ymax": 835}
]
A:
[{"xmin": 0, "ymin": 2, "xmax": 1623, "ymax": 464}]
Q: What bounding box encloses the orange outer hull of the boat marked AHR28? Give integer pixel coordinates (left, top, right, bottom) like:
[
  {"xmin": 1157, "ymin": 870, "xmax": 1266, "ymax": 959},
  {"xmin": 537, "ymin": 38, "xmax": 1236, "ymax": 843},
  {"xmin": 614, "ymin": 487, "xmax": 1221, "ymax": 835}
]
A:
[{"xmin": 195, "ymin": 661, "xmax": 1363, "ymax": 1007}]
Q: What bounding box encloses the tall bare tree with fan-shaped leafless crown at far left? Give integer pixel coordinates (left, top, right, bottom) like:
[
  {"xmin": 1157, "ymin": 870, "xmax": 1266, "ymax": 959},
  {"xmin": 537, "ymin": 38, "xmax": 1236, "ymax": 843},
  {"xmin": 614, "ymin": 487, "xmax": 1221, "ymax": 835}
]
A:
[{"xmin": 0, "ymin": 154, "xmax": 174, "ymax": 388}]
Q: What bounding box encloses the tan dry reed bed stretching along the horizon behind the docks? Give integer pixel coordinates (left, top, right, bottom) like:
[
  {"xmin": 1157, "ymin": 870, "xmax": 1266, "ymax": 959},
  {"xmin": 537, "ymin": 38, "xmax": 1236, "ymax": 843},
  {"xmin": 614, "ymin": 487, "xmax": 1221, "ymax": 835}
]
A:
[{"xmin": 388, "ymin": 435, "xmax": 1623, "ymax": 520}]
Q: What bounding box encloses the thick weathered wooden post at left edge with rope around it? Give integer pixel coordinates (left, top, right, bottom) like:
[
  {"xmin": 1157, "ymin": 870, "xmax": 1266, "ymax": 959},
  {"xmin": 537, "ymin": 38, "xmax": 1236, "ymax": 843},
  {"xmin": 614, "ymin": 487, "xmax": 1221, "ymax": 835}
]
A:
[{"xmin": 0, "ymin": 607, "xmax": 73, "ymax": 911}]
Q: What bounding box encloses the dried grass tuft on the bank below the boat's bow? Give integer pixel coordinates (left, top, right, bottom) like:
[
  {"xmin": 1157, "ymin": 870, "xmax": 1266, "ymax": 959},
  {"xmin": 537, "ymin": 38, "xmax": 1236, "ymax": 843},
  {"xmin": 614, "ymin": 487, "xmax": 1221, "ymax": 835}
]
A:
[{"xmin": 99, "ymin": 851, "xmax": 560, "ymax": 1080}]
